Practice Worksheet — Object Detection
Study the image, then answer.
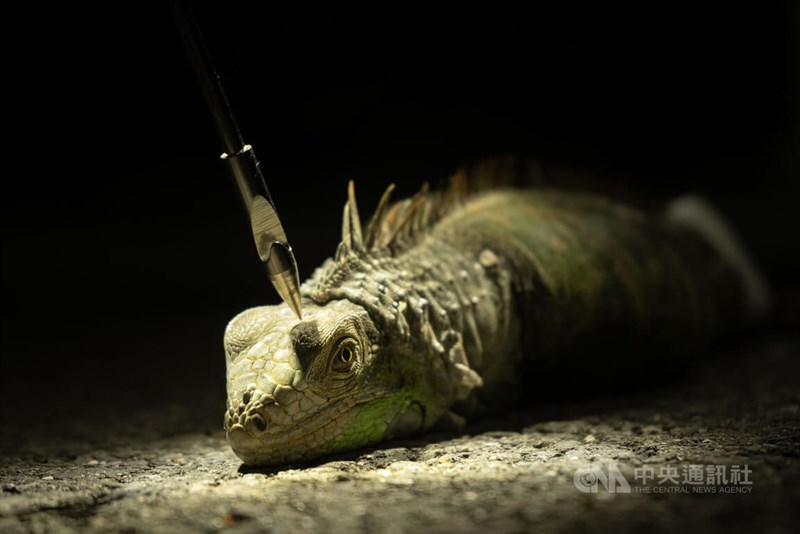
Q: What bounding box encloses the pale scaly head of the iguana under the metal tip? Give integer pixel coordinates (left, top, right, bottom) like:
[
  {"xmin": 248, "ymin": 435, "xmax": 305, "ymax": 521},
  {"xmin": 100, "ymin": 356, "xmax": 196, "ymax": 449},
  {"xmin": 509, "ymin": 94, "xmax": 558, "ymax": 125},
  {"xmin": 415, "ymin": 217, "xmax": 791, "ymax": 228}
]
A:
[{"xmin": 225, "ymin": 300, "xmax": 432, "ymax": 465}]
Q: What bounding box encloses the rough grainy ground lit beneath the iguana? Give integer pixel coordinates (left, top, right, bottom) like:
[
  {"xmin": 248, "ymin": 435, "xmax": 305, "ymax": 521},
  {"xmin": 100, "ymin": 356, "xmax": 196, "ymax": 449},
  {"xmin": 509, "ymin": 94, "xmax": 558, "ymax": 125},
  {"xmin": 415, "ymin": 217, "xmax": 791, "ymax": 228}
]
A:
[{"xmin": 0, "ymin": 340, "xmax": 800, "ymax": 534}]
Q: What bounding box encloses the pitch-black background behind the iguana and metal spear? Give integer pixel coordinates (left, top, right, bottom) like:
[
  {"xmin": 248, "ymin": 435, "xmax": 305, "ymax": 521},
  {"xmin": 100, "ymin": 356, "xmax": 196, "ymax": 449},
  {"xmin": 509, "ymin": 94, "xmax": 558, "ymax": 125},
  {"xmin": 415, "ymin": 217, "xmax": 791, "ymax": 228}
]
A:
[{"xmin": 0, "ymin": 2, "xmax": 800, "ymax": 426}]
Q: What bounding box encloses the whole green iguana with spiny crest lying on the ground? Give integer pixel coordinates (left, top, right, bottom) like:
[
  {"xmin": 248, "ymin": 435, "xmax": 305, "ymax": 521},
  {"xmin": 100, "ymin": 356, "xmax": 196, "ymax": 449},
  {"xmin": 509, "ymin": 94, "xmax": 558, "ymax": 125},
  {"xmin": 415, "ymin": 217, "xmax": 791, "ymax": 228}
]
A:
[{"xmin": 224, "ymin": 161, "xmax": 767, "ymax": 465}]
